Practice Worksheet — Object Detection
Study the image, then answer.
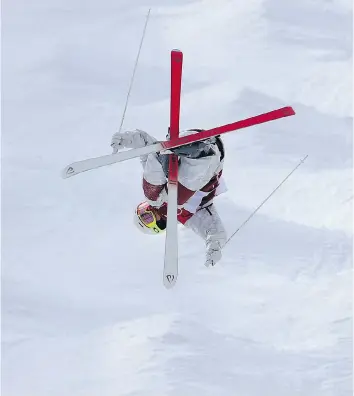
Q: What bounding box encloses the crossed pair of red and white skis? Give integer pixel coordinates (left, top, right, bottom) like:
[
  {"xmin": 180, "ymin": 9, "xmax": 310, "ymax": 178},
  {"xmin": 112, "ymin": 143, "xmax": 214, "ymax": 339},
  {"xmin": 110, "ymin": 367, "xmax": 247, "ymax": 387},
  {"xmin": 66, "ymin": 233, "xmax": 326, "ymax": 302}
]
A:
[{"xmin": 62, "ymin": 50, "xmax": 295, "ymax": 288}]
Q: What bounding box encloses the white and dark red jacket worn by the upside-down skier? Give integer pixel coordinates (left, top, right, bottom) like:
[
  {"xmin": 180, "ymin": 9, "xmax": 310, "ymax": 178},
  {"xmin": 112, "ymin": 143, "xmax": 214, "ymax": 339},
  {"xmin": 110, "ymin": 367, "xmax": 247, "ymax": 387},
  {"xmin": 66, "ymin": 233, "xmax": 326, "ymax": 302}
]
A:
[{"xmin": 112, "ymin": 129, "xmax": 227, "ymax": 254}]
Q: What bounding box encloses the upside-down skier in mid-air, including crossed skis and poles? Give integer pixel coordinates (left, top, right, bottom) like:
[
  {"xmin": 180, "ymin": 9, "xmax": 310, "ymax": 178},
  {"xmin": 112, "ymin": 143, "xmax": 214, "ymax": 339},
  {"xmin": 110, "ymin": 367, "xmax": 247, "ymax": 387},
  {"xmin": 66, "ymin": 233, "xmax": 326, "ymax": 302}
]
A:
[{"xmin": 62, "ymin": 41, "xmax": 297, "ymax": 288}]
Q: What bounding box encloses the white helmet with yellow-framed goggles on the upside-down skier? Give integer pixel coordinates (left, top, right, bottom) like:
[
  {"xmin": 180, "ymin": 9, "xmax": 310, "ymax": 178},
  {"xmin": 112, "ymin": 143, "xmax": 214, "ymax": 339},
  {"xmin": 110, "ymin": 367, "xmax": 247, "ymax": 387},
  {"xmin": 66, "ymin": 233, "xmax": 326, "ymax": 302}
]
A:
[{"xmin": 134, "ymin": 202, "xmax": 166, "ymax": 235}]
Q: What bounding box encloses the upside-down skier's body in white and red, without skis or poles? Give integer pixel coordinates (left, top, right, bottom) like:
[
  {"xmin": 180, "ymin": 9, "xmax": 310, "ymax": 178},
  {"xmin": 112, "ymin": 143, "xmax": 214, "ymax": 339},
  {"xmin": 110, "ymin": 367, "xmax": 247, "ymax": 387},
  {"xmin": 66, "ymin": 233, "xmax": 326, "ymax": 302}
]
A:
[{"xmin": 111, "ymin": 129, "xmax": 226, "ymax": 267}]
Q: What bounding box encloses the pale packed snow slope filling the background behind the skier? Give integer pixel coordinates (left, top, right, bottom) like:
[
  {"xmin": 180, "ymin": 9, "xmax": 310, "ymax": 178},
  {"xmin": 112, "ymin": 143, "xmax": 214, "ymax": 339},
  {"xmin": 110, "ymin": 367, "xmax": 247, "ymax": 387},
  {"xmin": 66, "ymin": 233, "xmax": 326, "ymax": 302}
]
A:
[{"xmin": 2, "ymin": 0, "xmax": 353, "ymax": 396}]
